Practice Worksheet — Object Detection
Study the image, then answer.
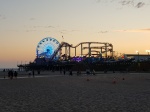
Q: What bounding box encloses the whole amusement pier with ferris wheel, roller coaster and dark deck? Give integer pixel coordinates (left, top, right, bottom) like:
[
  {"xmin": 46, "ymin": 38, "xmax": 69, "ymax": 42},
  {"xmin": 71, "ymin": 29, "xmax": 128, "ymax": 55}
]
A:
[{"xmin": 17, "ymin": 37, "xmax": 150, "ymax": 72}]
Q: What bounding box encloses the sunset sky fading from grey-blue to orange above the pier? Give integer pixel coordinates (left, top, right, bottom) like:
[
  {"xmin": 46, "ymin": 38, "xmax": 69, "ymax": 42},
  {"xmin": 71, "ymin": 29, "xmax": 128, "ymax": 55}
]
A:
[{"xmin": 0, "ymin": 0, "xmax": 150, "ymax": 68}]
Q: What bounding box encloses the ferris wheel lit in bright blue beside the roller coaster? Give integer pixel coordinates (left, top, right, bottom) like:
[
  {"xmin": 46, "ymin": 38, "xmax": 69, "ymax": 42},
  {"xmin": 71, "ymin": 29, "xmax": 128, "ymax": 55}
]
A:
[{"xmin": 36, "ymin": 37, "xmax": 60, "ymax": 59}]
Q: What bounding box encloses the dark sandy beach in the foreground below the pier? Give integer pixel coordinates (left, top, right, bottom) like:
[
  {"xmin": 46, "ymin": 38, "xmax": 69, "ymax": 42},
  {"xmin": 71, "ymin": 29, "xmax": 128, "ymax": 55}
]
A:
[{"xmin": 0, "ymin": 72, "xmax": 150, "ymax": 112}]
